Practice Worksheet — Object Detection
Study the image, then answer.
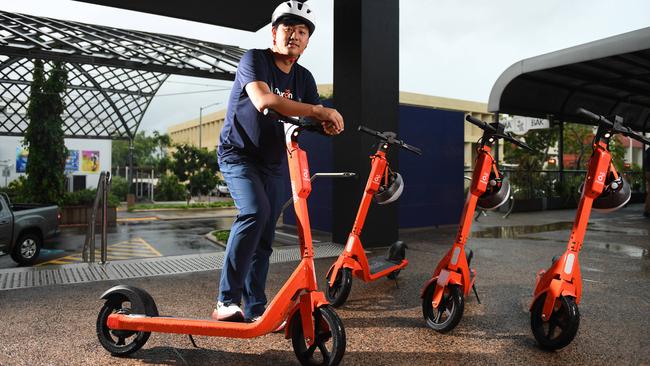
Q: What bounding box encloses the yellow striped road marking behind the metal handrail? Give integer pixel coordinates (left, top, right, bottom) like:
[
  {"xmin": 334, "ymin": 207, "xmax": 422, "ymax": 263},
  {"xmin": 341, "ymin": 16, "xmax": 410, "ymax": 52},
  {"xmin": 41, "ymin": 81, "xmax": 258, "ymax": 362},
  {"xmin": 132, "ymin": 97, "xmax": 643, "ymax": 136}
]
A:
[{"xmin": 36, "ymin": 238, "xmax": 162, "ymax": 266}]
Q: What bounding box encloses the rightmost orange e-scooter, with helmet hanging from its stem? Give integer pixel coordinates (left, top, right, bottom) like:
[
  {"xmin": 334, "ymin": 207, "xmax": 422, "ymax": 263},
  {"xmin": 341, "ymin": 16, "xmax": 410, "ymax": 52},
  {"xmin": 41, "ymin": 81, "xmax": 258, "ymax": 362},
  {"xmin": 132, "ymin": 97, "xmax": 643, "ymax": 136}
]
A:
[{"xmin": 530, "ymin": 108, "xmax": 650, "ymax": 350}]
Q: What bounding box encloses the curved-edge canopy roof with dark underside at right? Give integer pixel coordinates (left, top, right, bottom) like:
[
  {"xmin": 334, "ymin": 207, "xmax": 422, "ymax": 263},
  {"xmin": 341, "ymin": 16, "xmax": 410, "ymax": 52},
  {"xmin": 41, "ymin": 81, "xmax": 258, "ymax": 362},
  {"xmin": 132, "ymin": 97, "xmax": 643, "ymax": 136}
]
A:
[{"xmin": 488, "ymin": 27, "xmax": 650, "ymax": 132}]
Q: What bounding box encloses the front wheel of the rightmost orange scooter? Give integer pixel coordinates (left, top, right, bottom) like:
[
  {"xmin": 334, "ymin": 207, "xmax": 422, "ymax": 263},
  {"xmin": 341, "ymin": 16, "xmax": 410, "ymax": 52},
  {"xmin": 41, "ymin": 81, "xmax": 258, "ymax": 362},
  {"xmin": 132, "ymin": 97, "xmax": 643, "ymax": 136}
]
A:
[{"xmin": 530, "ymin": 294, "xmax": 580, "ymax": 351}]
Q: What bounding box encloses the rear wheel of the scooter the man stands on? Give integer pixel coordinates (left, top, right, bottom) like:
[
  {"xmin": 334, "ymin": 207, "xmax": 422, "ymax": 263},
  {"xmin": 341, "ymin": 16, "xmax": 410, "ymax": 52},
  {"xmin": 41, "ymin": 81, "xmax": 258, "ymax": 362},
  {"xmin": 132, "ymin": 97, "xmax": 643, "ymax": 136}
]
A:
[{"xmin": 97, "ymin": 295, "xmax": 151, "ymax": 356}]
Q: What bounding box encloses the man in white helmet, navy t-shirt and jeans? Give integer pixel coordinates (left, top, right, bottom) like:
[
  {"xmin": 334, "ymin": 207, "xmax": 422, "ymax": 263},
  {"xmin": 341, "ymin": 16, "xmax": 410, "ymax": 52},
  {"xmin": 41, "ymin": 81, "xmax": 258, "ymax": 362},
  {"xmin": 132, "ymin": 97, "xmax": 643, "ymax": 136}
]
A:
[{"xmin": 212, "ymin": 1, "xmax": 343, "ymax": 321}]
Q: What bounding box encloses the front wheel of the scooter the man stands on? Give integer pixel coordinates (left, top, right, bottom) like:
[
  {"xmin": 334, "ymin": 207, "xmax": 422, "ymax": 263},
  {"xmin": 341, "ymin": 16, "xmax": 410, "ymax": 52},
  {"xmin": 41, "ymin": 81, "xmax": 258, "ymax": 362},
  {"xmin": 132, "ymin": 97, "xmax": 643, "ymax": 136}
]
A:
[{"xmin": 290, "ymin": 306, "xmax": 345, "ymax": 366}]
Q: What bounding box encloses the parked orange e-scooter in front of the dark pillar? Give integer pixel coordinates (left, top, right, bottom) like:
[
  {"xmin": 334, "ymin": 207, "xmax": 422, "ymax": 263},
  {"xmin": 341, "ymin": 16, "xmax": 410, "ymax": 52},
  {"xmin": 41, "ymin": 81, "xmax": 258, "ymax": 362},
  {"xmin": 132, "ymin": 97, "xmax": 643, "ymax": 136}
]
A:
[{"xmin": 325, "ymin": 126, "xmax": 422, "ymax": 307}]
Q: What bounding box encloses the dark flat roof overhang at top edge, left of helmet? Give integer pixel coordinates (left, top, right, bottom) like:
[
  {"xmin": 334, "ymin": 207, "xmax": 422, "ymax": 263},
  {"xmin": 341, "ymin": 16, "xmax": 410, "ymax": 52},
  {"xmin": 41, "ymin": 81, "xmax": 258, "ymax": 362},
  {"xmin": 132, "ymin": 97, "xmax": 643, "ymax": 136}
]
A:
[{"xmin": 76, "ymin": 0, "xmax": 283, "ymax": 32}]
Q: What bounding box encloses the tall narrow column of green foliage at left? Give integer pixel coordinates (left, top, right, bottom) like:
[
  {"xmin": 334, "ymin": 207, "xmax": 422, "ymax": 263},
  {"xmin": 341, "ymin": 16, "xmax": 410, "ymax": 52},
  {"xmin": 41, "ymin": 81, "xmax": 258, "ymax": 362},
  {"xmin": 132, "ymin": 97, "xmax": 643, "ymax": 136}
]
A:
[{"xmin": 23, "ymin": 60, "xmax": 68, "ymax": 203}]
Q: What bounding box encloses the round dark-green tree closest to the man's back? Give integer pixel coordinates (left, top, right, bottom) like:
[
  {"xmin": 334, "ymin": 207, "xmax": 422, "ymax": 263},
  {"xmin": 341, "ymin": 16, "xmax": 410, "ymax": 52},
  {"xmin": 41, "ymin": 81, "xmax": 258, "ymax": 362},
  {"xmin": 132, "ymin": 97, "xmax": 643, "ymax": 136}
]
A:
[{"xmin": 172, "ymin": 144, "xmax": 219, "ymax": 200}]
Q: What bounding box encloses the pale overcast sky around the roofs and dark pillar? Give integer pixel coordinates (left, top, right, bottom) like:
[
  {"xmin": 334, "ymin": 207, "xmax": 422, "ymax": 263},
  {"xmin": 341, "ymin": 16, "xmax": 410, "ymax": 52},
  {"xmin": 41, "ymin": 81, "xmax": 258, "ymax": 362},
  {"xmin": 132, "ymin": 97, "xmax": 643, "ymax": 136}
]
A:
[{"xmin": 0, "ymin": 0, "xmax": 650, "ymax": 132}]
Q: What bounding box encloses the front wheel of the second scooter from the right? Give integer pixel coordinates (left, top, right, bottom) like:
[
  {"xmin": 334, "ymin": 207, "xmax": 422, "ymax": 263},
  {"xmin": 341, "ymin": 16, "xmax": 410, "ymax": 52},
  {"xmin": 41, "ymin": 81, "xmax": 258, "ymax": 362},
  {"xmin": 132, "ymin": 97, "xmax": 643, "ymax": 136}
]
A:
[{"xmin": 422, "ymin": 282, "xmax": 465, "ymax": 333}]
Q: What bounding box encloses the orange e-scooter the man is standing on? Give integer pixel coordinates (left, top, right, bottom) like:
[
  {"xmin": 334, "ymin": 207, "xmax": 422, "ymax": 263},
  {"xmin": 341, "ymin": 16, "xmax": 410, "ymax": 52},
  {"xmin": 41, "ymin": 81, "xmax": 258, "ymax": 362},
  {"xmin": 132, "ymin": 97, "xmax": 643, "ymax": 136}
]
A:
[{"xmin": 97, "ymin": 110, "xmax": 346, "ymax": 365}]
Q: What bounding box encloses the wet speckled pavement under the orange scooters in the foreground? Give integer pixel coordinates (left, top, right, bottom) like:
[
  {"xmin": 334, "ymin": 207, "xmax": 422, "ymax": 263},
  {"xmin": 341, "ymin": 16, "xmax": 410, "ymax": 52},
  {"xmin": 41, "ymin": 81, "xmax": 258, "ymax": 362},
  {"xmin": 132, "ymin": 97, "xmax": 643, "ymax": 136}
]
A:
[{"xmin": 0, "ymin": 205, "xmax": 650, "ymax": 365}]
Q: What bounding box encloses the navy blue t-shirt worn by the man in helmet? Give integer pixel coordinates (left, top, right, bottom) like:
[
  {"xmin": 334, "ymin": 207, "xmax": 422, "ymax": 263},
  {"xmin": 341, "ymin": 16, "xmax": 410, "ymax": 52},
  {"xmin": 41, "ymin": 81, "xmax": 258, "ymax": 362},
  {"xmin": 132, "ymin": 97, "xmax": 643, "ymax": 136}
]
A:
[{"xmin": 218, "ymin": 49, "xmax": 321, "ymax": 170}]
